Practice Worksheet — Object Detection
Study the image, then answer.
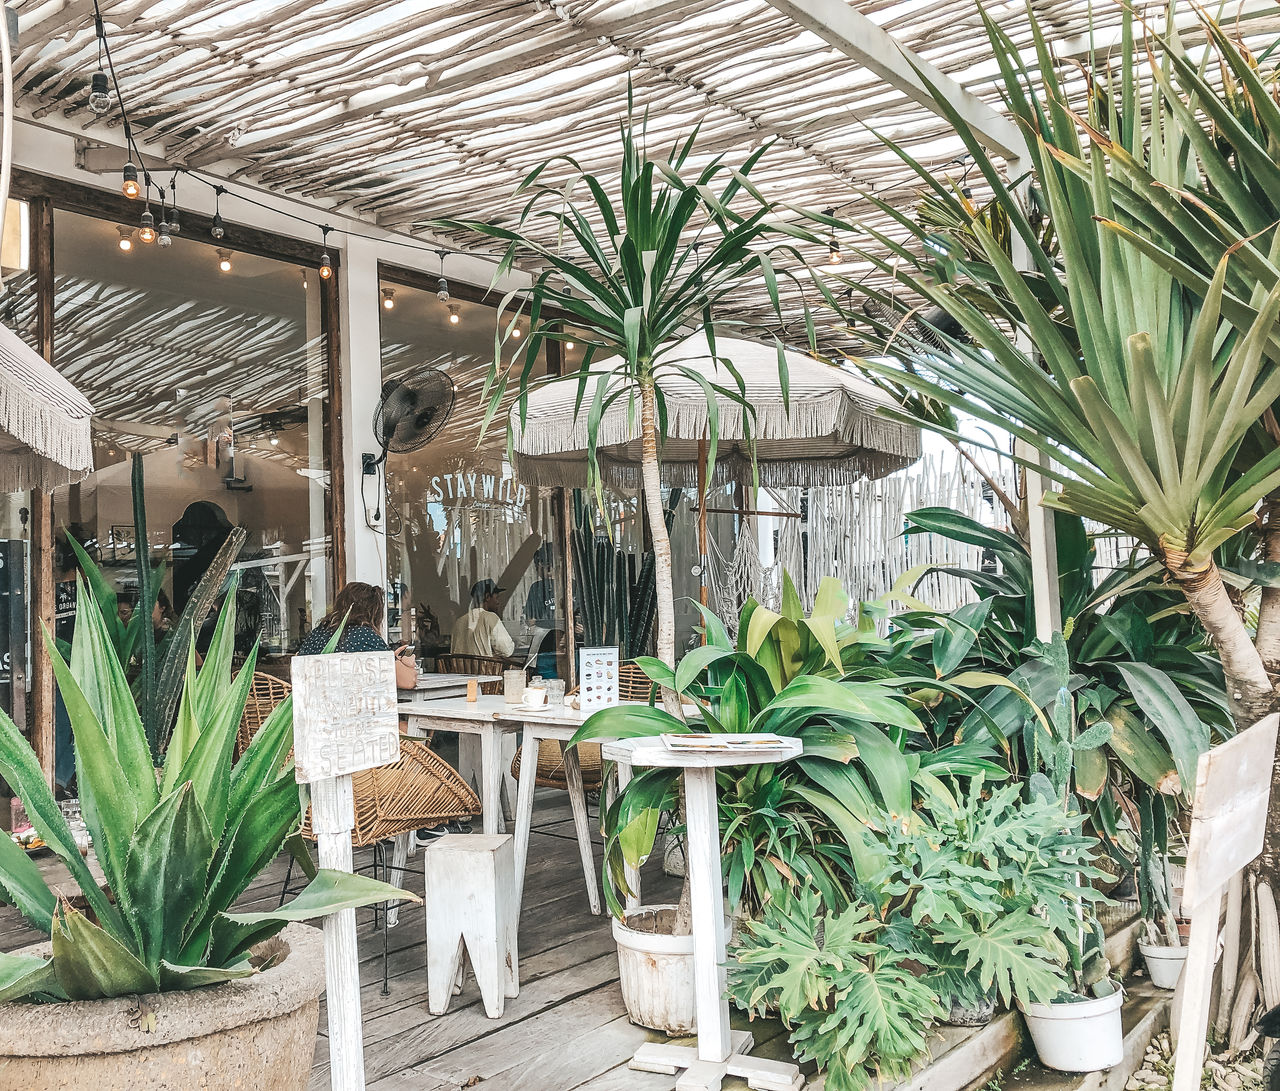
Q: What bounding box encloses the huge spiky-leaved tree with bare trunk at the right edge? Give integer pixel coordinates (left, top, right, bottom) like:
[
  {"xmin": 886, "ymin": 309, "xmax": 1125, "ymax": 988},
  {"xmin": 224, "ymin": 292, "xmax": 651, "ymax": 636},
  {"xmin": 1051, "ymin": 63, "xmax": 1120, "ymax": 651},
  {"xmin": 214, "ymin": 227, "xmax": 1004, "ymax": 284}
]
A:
[{"xmin": 815, "ymin": 4, "xmax": 1280, "ymax": 723}]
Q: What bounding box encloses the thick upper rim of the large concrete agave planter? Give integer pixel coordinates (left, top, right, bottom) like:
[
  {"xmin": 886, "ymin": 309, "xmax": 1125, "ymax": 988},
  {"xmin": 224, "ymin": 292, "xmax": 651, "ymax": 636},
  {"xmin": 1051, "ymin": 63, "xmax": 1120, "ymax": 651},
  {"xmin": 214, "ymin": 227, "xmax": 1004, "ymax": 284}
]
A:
[{"xmin": 0, "ymin": 925, "xmax": 325, "ymax": 1059}]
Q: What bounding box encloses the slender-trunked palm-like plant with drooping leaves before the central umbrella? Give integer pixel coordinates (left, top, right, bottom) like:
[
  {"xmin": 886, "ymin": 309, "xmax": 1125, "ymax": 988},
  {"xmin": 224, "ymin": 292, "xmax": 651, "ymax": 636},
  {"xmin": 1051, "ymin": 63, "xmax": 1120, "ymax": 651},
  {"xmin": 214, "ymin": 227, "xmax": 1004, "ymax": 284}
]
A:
[{"xmin": 440, "ymin": 97, "xmax": 818, "ymax": 701}]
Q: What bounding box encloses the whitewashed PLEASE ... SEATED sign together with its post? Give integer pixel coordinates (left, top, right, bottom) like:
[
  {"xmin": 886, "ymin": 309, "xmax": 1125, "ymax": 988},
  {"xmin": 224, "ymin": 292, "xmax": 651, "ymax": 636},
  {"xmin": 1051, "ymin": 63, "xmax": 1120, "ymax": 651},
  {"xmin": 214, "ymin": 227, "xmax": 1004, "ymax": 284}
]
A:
[{"xmin": 291, "ymin": 652, "xmax": 399, "ymax": 1091}]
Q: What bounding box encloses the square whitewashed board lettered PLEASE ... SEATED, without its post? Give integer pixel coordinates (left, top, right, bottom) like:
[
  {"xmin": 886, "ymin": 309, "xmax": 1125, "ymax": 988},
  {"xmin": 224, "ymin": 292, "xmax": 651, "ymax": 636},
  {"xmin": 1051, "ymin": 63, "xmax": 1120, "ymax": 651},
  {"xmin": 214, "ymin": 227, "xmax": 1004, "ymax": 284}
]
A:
[{"xmin": 291, "ymin": 652, "xmax": 399, "ymax": 784}]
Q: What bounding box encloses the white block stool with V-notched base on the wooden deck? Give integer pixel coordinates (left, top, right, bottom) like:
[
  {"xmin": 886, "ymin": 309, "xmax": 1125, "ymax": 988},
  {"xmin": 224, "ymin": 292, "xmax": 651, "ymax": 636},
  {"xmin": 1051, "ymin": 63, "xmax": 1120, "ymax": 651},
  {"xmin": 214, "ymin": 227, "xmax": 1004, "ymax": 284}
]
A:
[{"xmin": 422, "ymin": 834, "xmax": 520, "ymax": 1019}]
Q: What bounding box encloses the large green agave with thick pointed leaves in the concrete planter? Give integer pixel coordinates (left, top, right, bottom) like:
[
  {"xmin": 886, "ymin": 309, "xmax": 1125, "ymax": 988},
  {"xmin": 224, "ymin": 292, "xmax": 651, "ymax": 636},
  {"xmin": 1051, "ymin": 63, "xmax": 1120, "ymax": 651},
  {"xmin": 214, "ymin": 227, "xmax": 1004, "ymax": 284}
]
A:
[{"xmin": 0, "ymin": 584, "xmax": 411, "ymax": 1001}]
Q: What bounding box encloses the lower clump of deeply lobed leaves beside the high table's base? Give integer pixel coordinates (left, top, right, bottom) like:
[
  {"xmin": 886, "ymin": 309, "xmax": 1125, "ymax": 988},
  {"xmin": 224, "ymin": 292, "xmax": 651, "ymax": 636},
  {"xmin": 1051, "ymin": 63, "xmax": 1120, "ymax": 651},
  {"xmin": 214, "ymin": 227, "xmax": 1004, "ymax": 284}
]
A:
[{"xmin": 728, "ymin": 889, "xmax": 943, "ymax": 1091}]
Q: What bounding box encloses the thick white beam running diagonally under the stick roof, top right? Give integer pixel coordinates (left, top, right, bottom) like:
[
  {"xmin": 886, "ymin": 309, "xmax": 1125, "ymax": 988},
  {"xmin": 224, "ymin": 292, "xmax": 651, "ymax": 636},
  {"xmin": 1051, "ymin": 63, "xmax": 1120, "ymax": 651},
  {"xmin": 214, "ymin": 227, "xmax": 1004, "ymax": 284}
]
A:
[{"xmin": 769, "ymin": 0, "xmax": 1027, "ymax": 159}]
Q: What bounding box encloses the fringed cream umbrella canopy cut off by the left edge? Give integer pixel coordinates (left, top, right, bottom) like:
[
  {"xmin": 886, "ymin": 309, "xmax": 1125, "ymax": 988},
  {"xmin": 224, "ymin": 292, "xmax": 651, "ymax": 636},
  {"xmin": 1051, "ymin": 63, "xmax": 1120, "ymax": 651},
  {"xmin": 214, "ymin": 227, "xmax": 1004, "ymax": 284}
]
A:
[{"xmin": 0, "ymin": 325, "xmax": 93, "ymax": 493}]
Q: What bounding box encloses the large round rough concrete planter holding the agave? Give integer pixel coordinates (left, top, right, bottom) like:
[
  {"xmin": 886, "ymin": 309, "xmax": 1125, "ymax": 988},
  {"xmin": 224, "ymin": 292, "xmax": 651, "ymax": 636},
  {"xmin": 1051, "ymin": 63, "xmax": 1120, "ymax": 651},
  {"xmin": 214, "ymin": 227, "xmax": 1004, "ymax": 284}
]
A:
[{"xmin": 0, "ymin": 925, "xmax": 324, "ymax": 1091}]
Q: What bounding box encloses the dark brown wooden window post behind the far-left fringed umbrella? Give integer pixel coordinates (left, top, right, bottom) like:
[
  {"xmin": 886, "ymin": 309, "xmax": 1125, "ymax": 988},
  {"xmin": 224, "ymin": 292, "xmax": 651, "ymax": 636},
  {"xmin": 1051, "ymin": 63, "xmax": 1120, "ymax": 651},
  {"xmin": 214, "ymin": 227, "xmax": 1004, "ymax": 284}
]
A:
[{"xmin": 31, "ymin": 197, "xmax": 55, "ymax": 785}]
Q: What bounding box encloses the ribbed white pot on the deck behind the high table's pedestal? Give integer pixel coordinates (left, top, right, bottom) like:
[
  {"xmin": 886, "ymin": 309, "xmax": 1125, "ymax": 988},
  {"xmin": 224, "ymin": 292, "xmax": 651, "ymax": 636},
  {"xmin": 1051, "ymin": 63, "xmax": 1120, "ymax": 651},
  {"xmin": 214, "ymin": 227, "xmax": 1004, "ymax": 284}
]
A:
[{"xmin": 613, "ymin": 905, "xmax": 696, "ymax": 1036}]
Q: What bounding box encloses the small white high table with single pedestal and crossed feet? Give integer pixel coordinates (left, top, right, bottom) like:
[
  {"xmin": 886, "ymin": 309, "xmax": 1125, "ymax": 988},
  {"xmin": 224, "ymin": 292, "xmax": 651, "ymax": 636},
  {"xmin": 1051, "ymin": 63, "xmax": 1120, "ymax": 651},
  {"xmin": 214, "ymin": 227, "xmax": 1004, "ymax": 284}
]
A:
[{"xmin": 602, "ymin": 739, "xmax": 804, "ymax": 1091}]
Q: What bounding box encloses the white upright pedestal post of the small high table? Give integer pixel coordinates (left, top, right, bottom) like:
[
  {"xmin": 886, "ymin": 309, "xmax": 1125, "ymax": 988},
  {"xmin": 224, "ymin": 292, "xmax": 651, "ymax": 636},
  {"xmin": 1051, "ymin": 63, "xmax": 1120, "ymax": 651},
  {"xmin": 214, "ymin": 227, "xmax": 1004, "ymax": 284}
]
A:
[{"xmin": 685, "ymin": 768, "xmax": 732, "ymax": 1062}]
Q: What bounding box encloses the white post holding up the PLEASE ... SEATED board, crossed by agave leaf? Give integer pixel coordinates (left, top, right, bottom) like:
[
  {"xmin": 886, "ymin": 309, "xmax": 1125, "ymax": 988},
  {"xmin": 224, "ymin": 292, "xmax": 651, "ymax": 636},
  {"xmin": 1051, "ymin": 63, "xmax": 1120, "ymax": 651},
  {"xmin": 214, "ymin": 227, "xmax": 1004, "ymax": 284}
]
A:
[{"xmin": 311, "ymin": 776, "xmax": 365, "ymax": 1091}]
